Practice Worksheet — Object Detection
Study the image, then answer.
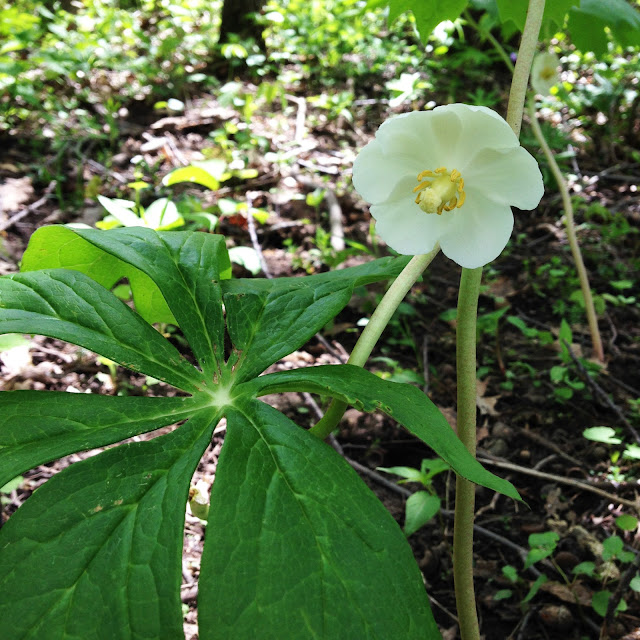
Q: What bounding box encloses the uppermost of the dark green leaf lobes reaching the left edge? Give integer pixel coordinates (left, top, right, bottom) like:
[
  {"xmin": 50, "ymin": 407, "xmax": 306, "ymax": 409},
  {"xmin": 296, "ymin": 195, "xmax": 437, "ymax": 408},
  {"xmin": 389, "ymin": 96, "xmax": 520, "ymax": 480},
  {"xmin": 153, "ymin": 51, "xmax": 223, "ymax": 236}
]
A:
[{"xmin": 0, "ymin": 269, "xmax": 202, "ymax": 391}]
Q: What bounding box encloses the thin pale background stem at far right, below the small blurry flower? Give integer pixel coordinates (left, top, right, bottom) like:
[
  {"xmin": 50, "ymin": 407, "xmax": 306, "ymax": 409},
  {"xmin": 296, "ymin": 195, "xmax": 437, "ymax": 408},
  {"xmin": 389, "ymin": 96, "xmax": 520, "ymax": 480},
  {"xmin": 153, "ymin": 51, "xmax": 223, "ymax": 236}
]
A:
[{"xmin": 529, "ymin": 100, "xmax": 604, "ymax": 362}]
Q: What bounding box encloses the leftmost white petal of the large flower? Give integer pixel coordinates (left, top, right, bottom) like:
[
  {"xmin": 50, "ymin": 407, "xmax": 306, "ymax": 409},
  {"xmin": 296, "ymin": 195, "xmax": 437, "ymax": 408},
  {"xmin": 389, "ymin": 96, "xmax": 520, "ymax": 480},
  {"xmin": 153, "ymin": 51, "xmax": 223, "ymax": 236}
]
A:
[{"xmin": 353, "ymin": 139, "xmax": 421, "ymax": 204}]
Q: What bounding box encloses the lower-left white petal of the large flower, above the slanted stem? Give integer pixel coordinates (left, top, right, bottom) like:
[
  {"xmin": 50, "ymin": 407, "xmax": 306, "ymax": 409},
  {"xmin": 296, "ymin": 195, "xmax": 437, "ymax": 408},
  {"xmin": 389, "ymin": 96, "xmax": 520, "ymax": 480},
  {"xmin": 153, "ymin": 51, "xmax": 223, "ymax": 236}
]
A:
[{"xmin": 371, "ymin": 180, "xmax": 447, "ymax": 256}]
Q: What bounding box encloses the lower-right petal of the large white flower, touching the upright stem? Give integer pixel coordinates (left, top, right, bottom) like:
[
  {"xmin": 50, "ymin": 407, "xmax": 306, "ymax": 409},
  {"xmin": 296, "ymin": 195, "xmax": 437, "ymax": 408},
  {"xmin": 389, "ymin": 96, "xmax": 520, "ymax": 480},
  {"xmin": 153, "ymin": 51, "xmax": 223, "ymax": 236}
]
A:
[{"xmin": 440, "ymin": 190, "xmax": 513, "ymax": 269}]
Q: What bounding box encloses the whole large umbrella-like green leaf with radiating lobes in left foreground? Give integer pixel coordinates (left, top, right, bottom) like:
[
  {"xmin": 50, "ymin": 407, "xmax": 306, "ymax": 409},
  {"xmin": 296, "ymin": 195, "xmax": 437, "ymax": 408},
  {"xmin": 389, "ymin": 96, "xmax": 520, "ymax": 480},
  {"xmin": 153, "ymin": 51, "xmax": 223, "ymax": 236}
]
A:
[{"xmin": 0, "ymin": 226, "xmax": 518, "ymax": 640}]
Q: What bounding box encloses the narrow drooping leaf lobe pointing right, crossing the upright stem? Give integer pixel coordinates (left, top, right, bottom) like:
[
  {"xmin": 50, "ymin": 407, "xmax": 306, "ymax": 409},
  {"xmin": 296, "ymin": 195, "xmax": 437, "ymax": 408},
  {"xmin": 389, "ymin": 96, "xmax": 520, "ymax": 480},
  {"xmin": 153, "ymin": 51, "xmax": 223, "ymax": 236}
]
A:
[{"xmin": 242, "ymin": 364, "xmax": 521, "ymax": 500}]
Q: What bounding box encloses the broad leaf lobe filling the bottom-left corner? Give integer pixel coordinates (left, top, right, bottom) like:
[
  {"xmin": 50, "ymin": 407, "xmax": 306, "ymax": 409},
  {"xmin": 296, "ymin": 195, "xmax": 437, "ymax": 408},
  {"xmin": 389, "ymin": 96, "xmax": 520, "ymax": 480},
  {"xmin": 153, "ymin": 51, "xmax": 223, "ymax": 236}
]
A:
[{"xmin": 0, "ymin": 410, "xmax": 218, "ymax": 640}]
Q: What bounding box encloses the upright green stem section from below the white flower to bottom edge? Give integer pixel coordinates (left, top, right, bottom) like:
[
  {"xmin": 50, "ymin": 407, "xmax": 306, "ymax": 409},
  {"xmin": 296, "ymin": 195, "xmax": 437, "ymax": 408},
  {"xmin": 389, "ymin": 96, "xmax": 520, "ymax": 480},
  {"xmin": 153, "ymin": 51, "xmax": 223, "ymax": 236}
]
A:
[{"xmin": 453, "ymin": 267, "xmax": 482, "ymax": 640}]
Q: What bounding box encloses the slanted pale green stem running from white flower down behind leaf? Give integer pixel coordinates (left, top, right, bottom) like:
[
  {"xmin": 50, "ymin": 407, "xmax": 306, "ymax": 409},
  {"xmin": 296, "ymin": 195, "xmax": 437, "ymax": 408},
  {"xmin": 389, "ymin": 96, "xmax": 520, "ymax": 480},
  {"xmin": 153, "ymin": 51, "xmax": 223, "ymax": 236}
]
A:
[{"xmin": 309, "ymin": 244, "xmax": 440, "ymax": 439}]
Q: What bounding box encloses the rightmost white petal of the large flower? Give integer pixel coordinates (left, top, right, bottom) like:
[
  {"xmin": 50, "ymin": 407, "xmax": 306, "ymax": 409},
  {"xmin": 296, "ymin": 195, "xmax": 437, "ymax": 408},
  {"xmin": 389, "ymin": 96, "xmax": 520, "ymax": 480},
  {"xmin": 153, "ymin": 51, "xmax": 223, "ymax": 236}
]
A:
[{"xmin": 464, "ymin": 147, "xmax": 544, "ymax": 210}]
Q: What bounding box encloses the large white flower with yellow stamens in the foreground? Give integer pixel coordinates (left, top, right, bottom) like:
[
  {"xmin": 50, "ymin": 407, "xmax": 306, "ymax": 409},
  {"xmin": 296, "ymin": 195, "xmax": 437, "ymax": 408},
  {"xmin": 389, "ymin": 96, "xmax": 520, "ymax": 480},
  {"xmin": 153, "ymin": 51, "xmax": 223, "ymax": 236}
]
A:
[{"xmin": 353, "ymin": 104, "xmax": 543, "ymax": 269}]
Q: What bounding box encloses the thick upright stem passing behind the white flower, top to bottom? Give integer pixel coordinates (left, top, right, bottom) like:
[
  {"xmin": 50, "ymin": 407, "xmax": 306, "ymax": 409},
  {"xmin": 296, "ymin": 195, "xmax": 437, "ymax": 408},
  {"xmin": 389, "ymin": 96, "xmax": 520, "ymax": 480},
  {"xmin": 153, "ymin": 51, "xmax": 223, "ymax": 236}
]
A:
[{"xmin": 453, "ymin": 0, "xmax": 545, "ymax": 640}]
